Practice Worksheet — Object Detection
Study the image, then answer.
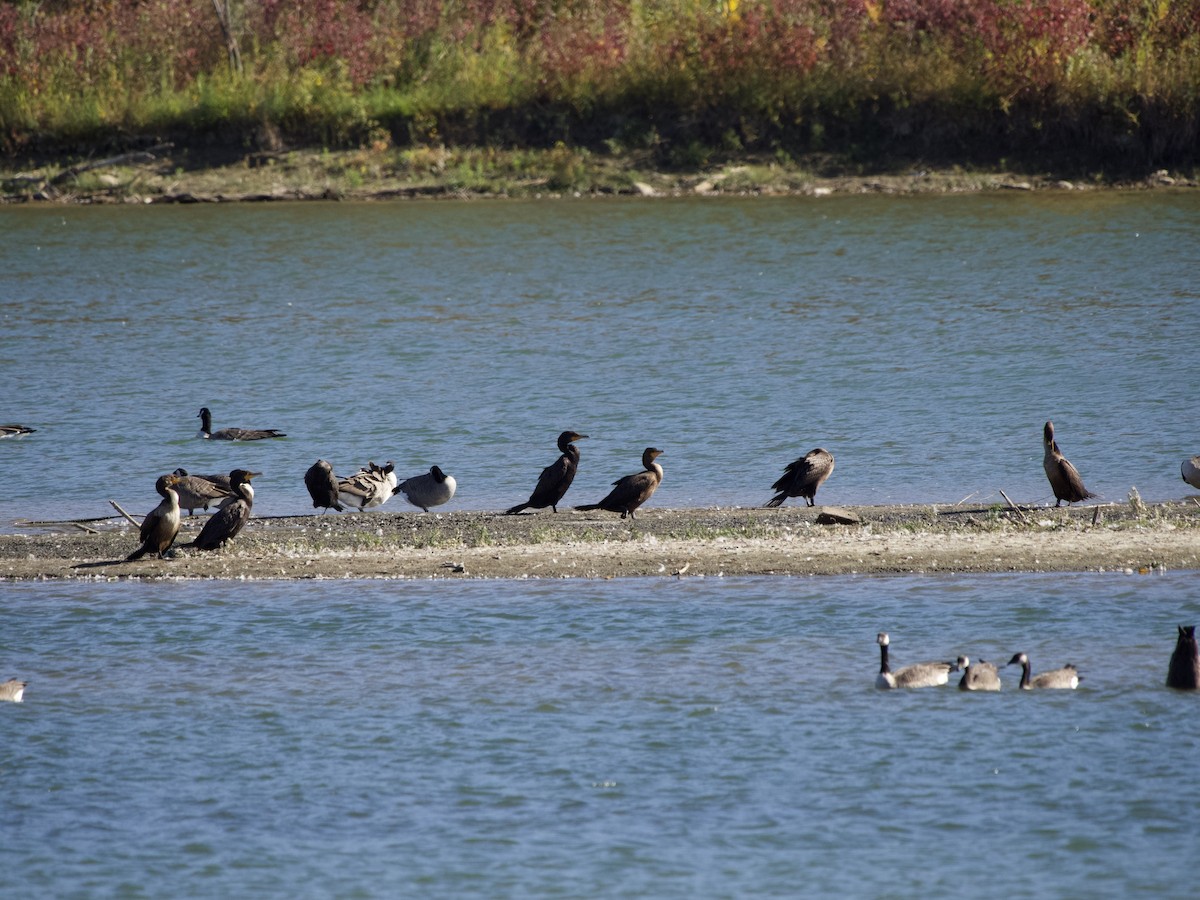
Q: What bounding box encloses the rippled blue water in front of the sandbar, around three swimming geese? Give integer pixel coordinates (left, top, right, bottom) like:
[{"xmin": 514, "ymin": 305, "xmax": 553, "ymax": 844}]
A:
[{"xmin": 0, "ymin": 572, "xmax": 1200, "ymax": 898}]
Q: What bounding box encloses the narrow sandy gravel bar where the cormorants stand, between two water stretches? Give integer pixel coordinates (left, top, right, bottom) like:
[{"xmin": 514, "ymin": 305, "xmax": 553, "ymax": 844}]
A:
[{"xmin": 0, "ymin": 498, "xmax": 1200, "ymax": 582}]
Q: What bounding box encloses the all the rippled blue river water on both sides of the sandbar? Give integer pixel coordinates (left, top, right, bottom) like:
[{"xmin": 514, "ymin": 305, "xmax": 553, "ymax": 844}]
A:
[{"xmin": 0, "ymin": 193, "xmax": 1200, "ymax": 898}]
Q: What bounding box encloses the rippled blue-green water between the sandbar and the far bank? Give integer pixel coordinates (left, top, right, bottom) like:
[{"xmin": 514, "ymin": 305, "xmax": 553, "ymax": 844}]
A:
[{"xmin": 0, "ymin": 193, "xmax": 1200, "ymax": 522}]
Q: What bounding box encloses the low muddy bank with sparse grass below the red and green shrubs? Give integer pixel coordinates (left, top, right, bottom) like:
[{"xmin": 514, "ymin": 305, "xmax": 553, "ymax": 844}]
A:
[{"xmin": 0, "ymin": 144, "xmax": 1200, "ymax": 205}]
